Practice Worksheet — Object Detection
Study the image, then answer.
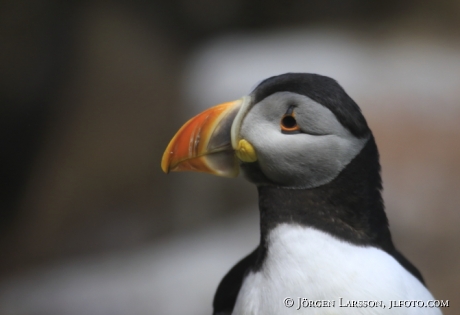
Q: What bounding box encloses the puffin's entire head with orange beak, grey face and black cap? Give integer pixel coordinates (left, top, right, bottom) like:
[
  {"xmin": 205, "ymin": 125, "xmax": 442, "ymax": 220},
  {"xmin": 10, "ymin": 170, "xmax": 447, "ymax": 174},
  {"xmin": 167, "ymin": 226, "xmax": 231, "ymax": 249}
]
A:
[{"xmin": 161, "ymin": 73, "xmax": 372, "ymax": 189}]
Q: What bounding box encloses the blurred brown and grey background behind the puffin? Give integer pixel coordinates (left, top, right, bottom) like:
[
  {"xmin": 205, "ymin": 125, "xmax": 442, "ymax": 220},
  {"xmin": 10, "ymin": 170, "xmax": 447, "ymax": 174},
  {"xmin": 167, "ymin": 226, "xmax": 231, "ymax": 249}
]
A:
[{"xmin": 0, "ymin": 0, "xmax": 460, "ymax": 315}]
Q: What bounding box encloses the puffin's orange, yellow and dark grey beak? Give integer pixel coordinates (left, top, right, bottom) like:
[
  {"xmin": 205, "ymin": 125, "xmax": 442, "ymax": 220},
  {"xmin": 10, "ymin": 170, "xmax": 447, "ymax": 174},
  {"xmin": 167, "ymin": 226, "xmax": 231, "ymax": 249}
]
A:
[{"xmin": 161, "ymin": 98, "xmax": 245, "ymax": 177}]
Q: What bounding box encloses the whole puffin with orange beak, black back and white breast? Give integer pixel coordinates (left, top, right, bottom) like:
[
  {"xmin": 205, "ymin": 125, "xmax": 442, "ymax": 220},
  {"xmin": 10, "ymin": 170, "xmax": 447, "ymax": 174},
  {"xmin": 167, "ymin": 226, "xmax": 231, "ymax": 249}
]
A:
[{"xmin": 161, "ymin": 73, "xmax": 441, "ymax": 315}]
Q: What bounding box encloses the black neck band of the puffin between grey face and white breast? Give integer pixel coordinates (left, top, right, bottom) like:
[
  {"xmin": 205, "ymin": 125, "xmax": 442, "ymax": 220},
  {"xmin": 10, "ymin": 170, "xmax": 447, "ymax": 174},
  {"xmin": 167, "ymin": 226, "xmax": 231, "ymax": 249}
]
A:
[{"xmin": 250, "ymin": 135, "xmax": 395, "ymax": 272}]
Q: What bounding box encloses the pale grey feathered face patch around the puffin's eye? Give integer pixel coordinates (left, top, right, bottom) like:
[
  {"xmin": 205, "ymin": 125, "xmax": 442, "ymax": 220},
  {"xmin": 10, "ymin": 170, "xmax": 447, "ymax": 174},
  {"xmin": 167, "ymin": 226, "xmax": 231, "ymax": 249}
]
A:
[{"xmin": 240, "ymin": 92, "xmax": 369, "ymax": 188}]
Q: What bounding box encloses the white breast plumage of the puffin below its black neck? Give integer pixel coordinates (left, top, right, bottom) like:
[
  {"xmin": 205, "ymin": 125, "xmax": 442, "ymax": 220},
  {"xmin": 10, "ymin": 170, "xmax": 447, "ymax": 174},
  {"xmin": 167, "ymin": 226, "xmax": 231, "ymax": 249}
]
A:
[{"xmin": 233, "ymin": 224, "xmax": 441, "ymax": 315}]
